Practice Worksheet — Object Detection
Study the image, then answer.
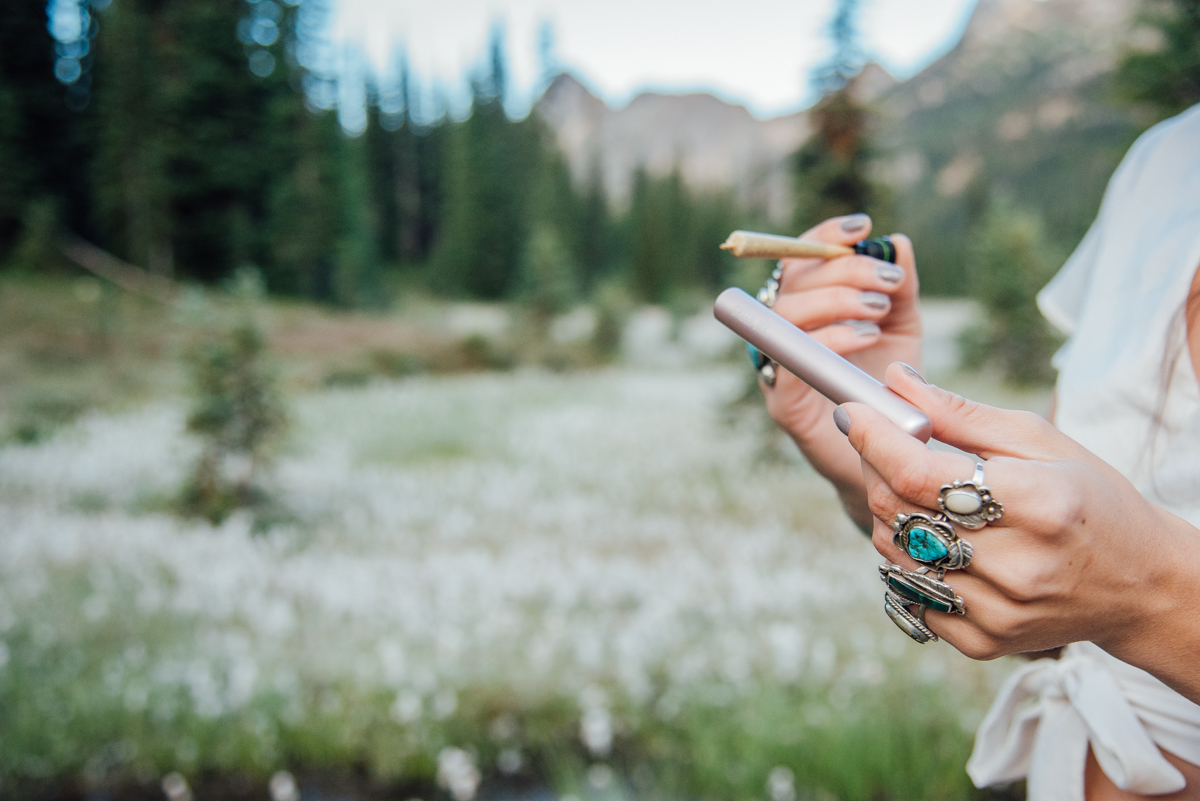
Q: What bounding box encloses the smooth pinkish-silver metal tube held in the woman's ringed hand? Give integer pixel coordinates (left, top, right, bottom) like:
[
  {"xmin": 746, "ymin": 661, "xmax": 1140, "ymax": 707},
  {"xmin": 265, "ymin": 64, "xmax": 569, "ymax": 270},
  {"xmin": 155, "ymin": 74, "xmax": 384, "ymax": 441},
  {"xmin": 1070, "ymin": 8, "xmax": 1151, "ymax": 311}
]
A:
[{"xmin": 713, "ymin": 287, "xmax": 934, "ymax": 442}]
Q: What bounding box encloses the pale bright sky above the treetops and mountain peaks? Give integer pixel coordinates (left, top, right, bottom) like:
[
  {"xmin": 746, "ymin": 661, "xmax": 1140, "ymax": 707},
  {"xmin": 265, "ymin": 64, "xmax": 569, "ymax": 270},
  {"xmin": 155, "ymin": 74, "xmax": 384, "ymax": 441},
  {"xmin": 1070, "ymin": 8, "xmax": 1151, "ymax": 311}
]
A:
[{"xmin": 332, "ymin": 0, "xmax": 976, "ymax": 119}]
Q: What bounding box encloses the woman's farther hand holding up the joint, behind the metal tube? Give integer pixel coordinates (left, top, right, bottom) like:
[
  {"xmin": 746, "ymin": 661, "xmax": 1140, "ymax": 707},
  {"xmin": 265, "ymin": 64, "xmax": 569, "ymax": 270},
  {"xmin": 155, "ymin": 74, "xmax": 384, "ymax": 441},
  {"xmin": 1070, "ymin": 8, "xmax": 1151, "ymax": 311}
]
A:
[{"xmin": 762, "ymin": 215, "xmax": 922, "ymax": 531}]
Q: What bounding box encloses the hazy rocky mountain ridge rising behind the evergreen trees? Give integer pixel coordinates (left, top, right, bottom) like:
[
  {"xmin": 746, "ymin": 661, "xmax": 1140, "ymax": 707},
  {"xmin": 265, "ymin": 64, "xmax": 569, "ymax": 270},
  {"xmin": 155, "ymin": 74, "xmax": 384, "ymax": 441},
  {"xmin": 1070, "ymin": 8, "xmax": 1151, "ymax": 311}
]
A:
[{"xmin": 535, "ymin": 0, "xmax": 1145, "ymax": 241}]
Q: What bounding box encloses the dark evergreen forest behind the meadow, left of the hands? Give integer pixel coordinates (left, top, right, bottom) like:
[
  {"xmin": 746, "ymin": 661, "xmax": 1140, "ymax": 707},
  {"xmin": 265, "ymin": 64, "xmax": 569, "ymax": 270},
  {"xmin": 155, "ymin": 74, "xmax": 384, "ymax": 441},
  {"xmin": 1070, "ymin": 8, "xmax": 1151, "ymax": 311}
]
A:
[{"xmin": 0, "ymin": 0, "xmax": 739, "ymax": 311}]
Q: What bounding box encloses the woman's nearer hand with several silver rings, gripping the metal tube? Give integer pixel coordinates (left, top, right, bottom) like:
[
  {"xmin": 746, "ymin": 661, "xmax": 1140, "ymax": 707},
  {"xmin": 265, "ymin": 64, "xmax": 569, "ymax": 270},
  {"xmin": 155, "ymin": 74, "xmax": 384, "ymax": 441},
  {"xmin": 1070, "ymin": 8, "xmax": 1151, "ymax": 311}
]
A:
[{"xmin": 839, "ymin": 365, "xmax": 1200, "ymax": 700}]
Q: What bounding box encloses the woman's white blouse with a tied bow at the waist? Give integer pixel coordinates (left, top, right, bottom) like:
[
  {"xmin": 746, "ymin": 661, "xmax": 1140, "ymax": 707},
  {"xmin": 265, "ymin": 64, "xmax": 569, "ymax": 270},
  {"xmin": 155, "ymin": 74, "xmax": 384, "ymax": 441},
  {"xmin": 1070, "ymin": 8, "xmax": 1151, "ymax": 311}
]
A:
[{"xmin": 967, "ymin": 106, "xmax": 1200, "ymax": 801}]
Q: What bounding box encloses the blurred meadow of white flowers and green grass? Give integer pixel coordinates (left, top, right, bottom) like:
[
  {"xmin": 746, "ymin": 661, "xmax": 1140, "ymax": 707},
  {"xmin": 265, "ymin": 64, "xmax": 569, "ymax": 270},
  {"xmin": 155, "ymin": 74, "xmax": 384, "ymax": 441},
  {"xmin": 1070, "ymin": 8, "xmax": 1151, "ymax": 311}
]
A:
[{"xmin": 0, "ymin": 293, "xmax": 1032, "ymax": 801}]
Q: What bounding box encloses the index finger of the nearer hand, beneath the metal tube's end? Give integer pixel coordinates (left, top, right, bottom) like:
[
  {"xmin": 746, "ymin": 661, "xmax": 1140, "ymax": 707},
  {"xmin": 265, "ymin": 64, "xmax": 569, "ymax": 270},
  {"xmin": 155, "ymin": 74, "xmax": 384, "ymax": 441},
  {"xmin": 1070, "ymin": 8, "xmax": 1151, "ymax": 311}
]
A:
[{"xmin": 841, "ymin": 403, "xmax": 974, "ymax": 510}]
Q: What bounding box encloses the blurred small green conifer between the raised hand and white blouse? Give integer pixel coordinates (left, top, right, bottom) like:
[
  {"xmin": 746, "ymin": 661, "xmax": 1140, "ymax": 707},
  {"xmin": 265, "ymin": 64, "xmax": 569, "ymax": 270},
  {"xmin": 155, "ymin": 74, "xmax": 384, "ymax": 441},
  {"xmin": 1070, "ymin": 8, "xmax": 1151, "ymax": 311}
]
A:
[{"xmin": 960, "ymin": 203, "xmax": 1061, "ymax": 385}]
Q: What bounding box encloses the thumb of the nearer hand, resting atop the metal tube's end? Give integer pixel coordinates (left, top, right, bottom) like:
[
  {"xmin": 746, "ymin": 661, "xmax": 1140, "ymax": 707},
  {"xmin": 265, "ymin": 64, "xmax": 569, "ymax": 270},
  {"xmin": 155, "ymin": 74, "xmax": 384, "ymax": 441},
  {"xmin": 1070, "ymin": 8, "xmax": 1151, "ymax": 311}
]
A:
[{"xmin": 883, "ymin": 362, "xmax": 1057, "ymax": 460}]
